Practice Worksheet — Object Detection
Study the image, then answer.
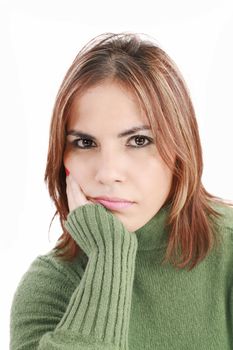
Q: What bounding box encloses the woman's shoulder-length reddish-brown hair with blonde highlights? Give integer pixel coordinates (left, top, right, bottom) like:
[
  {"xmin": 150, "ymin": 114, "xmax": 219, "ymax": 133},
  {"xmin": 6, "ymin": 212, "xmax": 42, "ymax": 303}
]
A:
[{"xmin": 45, "ymin": 33, "xmax": 232, "ymax": 269}]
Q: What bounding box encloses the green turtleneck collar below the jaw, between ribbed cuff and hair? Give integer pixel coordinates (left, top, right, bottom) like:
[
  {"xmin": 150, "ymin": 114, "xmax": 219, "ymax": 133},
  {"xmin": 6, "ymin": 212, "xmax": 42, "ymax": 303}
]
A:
[{"xmin": 134, "ymin": 203, "xmax": 171, "ymax": 250}]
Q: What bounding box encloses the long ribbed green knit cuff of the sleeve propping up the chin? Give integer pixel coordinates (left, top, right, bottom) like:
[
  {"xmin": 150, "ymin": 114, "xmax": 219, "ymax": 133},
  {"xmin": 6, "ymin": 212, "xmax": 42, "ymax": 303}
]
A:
[{"xmin": 10, "ymin": 204, "xmax": 137, "ymax": 350}]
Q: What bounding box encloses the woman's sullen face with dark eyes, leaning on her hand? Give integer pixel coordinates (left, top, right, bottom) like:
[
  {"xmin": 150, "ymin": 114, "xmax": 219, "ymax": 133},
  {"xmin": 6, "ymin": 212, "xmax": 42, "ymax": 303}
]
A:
[{"xmin": 64, "ymin": 82, "xmax": 172, "ymax": 232}]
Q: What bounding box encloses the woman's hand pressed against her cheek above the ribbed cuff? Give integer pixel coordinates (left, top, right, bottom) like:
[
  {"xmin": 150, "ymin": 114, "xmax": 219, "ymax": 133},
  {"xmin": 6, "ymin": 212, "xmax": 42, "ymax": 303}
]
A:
[{"xmin": 66, "ymin": 169, "xmax": 93, "ymax": 212}]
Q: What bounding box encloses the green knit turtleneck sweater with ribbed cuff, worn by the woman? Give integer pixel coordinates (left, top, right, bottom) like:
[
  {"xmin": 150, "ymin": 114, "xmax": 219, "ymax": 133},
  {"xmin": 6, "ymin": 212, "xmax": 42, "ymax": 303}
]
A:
[{"xmin": 10, "ymin": 204, "xmax": 233, "ymax": 350}]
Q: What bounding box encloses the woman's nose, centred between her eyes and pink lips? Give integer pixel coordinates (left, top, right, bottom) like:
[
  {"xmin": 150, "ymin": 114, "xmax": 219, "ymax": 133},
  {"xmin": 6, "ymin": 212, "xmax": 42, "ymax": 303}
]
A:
[{"xmin": 95, "ymin": 147, "xmax": 125, "ymax": 185}]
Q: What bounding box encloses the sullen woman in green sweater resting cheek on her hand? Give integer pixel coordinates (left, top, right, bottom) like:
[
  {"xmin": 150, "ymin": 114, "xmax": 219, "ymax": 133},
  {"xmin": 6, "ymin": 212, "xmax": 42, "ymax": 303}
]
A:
[{"xmin": 11, "ymin": 33, "xmax": 233, "ymax": 350}]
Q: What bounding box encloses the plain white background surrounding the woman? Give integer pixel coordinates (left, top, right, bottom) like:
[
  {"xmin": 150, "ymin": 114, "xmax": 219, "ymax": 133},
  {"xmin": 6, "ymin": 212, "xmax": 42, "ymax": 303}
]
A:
[{"xmin": 0, "ymin": 0, "xmax": 233, "ymax": 349}]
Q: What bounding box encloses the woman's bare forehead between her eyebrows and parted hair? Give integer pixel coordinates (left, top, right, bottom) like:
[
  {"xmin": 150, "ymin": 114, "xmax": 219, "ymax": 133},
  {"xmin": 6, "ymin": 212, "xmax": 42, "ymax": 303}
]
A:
[{"xmin": 68, "ymin": 82, "xmax": 149, "ymax": 128}]
